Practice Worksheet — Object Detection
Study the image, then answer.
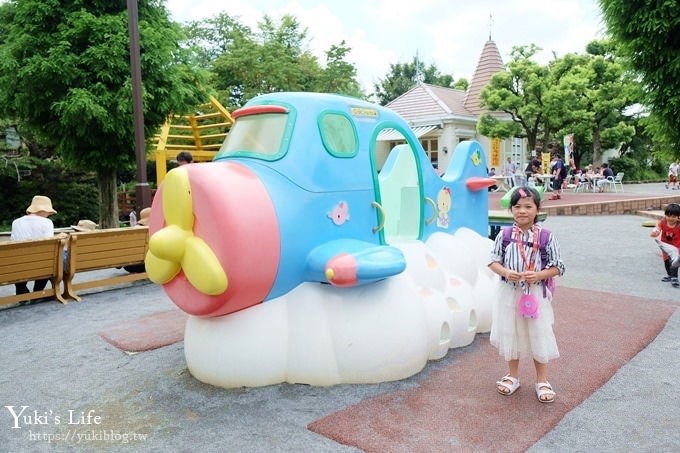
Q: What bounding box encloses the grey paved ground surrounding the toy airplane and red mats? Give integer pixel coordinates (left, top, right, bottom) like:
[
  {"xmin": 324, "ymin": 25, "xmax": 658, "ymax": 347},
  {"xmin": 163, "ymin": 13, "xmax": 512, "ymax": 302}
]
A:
[{"xmin": 0, "ymin": 184, "xmax": 680, "ymax": 453}]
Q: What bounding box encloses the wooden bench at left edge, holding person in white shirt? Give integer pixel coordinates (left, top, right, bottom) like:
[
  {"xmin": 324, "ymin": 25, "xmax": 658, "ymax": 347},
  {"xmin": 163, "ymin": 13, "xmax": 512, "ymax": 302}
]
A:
[{"xmin": 0, "ymin": 237, "xmax": 66, "ymax": 305}]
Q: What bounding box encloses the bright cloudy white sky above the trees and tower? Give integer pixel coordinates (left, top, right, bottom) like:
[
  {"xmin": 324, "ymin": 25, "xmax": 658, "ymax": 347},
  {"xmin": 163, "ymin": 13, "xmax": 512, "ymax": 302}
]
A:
[{"xmin": 166, "ymin": 0, "xmax": 604, "ymax": 93}]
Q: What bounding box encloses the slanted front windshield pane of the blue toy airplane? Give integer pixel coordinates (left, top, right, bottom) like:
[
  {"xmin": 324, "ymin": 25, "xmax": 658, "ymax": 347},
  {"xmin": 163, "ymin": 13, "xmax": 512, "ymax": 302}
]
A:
[{"xmin": 215, "ymin": 113, "xmax": 288, "ymax": 160}]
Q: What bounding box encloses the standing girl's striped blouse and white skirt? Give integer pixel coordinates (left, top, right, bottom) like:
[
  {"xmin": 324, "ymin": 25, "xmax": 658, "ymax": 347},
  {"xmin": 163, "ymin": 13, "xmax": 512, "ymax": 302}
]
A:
[{"xmin": 490, "ymin": 226, "xmax": 565, "ymax": 363}]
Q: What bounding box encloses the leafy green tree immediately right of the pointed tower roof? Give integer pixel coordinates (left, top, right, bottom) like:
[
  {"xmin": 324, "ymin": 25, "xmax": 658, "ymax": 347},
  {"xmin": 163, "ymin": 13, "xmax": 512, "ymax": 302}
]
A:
[{"xmin": 477, "ymin": 44, "xmax": 549, "ymax": 150}]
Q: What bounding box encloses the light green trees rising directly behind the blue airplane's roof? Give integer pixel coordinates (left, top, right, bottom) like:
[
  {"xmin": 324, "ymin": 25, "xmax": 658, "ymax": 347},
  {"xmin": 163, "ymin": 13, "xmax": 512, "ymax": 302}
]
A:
[{"xmin": 184, "ymin": 13, "xmax": 365, "ymax": 108}]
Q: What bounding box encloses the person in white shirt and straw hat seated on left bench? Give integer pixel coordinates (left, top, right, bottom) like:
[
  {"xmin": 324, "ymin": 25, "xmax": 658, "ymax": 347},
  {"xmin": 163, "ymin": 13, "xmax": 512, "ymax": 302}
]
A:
[{"xmin": 10, "ymin": 195, "xmax": 57, "ymax": 294}]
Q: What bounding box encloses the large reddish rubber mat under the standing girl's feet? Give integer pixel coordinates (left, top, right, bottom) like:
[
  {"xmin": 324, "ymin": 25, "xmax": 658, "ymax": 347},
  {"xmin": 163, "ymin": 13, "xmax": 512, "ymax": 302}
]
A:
[{"xmin": 308, "ymin": 287, "xmax": 676, "ymax": 453}]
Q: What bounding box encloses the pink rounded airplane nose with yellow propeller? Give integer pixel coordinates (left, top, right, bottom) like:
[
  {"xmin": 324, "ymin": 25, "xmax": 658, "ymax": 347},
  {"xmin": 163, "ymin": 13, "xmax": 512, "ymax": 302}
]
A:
[{"xmin": 146, "ymin": 162, "xmax": 280, "ymax": 316}]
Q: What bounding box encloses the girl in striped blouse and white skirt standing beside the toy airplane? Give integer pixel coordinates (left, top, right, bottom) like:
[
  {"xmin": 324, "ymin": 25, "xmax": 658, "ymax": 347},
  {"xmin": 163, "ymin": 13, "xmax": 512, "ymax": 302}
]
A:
[{"xmin": 489, "ymin": 187, "xmax": 565, "ymax": 403}]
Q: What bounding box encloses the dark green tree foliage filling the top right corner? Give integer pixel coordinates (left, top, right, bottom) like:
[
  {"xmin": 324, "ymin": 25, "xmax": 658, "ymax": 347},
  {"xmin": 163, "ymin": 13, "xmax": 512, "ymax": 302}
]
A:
[{"xmin": 599, "ymin": 0, "xmax": 680, "ymax": 151}]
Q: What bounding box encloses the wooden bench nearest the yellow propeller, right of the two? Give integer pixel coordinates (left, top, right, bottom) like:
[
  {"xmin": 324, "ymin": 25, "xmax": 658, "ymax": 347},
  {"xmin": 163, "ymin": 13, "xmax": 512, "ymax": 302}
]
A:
[{"xmin": 64, "ymin": 226, "xmax": 149, "ymax": 302}]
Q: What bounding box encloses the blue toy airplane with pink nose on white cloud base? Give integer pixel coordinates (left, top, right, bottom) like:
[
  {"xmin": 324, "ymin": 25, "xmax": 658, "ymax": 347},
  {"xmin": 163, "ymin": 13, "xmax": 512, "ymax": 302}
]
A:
[{"xmin": 146, "ymin": 93, "xmax": 500, "ymax": 388}]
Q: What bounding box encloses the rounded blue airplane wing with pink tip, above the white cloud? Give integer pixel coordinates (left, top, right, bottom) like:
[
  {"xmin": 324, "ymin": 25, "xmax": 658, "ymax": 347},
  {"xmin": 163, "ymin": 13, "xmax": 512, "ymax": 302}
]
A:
[{"xmin": 307, "ymin": 239, "xmax": 406, "ymax": 287}]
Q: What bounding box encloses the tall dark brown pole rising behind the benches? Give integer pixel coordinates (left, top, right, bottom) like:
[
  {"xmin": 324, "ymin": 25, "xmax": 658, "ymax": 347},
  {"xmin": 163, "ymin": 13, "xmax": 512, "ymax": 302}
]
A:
[{"xmin": 127, "ymin": 0, "xmax": 151, "ymax": 209}]
